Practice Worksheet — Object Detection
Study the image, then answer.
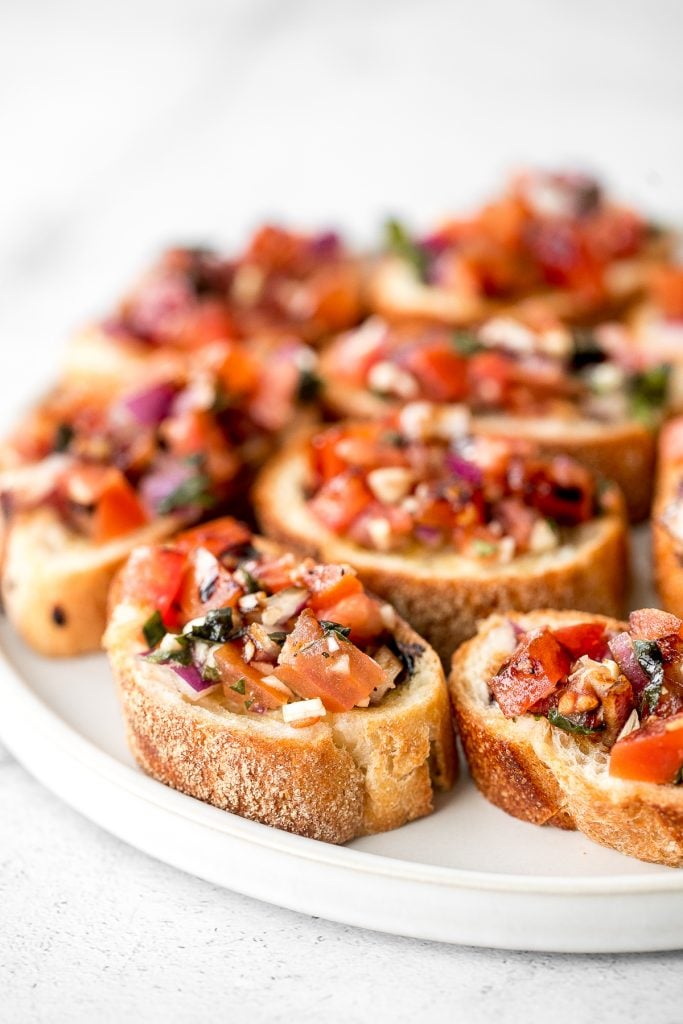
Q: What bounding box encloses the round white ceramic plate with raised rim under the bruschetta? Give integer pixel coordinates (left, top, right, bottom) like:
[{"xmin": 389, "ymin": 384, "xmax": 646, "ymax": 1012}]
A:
[{"xmin": 0, "ymin": 536, "xmax": 683, "ymax": 952}]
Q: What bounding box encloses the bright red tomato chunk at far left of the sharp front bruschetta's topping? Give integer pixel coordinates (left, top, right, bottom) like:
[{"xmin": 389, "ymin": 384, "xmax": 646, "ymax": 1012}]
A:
[{"xmin": 119, "ymin": 546, "xmax": 185, "ymax": 629}]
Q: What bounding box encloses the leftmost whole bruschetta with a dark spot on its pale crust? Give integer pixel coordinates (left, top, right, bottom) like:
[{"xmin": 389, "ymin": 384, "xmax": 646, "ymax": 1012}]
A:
[{"xmin": 0, "ymin": 331, "xmax": 319, "ymax": 654}]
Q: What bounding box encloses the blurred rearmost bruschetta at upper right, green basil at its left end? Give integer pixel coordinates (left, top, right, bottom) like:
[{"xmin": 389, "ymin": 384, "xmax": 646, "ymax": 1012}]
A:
[{"xmin": 370, "ymin": 172, "xmax": 670, "ymax": 326}]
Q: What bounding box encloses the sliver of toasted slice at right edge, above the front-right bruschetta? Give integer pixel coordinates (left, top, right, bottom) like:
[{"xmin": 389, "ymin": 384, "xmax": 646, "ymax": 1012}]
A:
[{"xmin": 652, "ymin": 417, "xmax": 683, "ymax": 616}]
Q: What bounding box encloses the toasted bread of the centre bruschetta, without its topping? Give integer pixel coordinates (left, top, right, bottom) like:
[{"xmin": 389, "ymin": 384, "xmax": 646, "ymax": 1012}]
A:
[{"xmin": 254, "ymin": 440, "xmax": 628, "ymax": 660}]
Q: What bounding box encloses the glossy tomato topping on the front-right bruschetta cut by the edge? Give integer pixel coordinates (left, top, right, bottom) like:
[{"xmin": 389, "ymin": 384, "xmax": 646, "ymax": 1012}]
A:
[{"xmin": 489, "ymin": 608, "xmax": 683, "ymax": 783}]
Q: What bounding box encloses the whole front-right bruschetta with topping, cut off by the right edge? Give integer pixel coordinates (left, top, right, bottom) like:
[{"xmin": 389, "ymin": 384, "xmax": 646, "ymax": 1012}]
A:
[{"xmin": 450, "ymin": 608, "xmax": 683, "ymax": 866}]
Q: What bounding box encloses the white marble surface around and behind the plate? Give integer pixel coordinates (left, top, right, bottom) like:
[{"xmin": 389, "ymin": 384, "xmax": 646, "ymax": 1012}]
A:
[{"xmin": 0, "ymin": 0, "xmax": 683, "ymax": 1024}]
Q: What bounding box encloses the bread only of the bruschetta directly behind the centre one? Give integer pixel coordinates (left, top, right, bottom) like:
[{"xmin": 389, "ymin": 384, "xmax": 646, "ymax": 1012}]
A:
[{"xmin": 322, "ymin": 368, "xmax": 656, "ymax": 522}]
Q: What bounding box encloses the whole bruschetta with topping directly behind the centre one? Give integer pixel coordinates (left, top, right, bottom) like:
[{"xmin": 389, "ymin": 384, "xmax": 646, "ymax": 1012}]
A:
[{"xmin": 321, "ymin": 314, "xmax": 673, "ymax": 520}]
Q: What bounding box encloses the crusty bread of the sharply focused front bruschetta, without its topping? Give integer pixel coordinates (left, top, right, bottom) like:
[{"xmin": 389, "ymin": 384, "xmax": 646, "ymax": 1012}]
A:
[{"xmin": 104, "ymin": 538, "xmax": 457, "ymax": 843}]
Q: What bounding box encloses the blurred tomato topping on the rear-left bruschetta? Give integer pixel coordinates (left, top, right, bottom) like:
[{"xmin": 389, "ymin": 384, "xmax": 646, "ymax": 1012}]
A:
[{"xmin": 104, "ymin": 225, "xmax": 360, "ymax": 349}]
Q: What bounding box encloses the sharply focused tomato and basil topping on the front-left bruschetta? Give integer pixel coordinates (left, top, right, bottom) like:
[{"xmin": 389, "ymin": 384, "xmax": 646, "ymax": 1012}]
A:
[{"xmin": 119, "ymin": 518, "xmax": 409, "ymax": 725}]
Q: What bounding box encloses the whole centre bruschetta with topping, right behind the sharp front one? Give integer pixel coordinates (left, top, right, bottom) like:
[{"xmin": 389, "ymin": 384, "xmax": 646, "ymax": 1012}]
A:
[{"xmin": 254, "ymin": 402, "xmax": 628, "ymax": 659}]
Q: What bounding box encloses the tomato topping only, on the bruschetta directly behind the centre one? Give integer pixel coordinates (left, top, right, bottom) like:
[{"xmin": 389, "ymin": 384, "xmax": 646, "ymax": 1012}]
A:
[{"xmin": 323, "ymin": 311, "xmax": 668, "ymax": 422}]
